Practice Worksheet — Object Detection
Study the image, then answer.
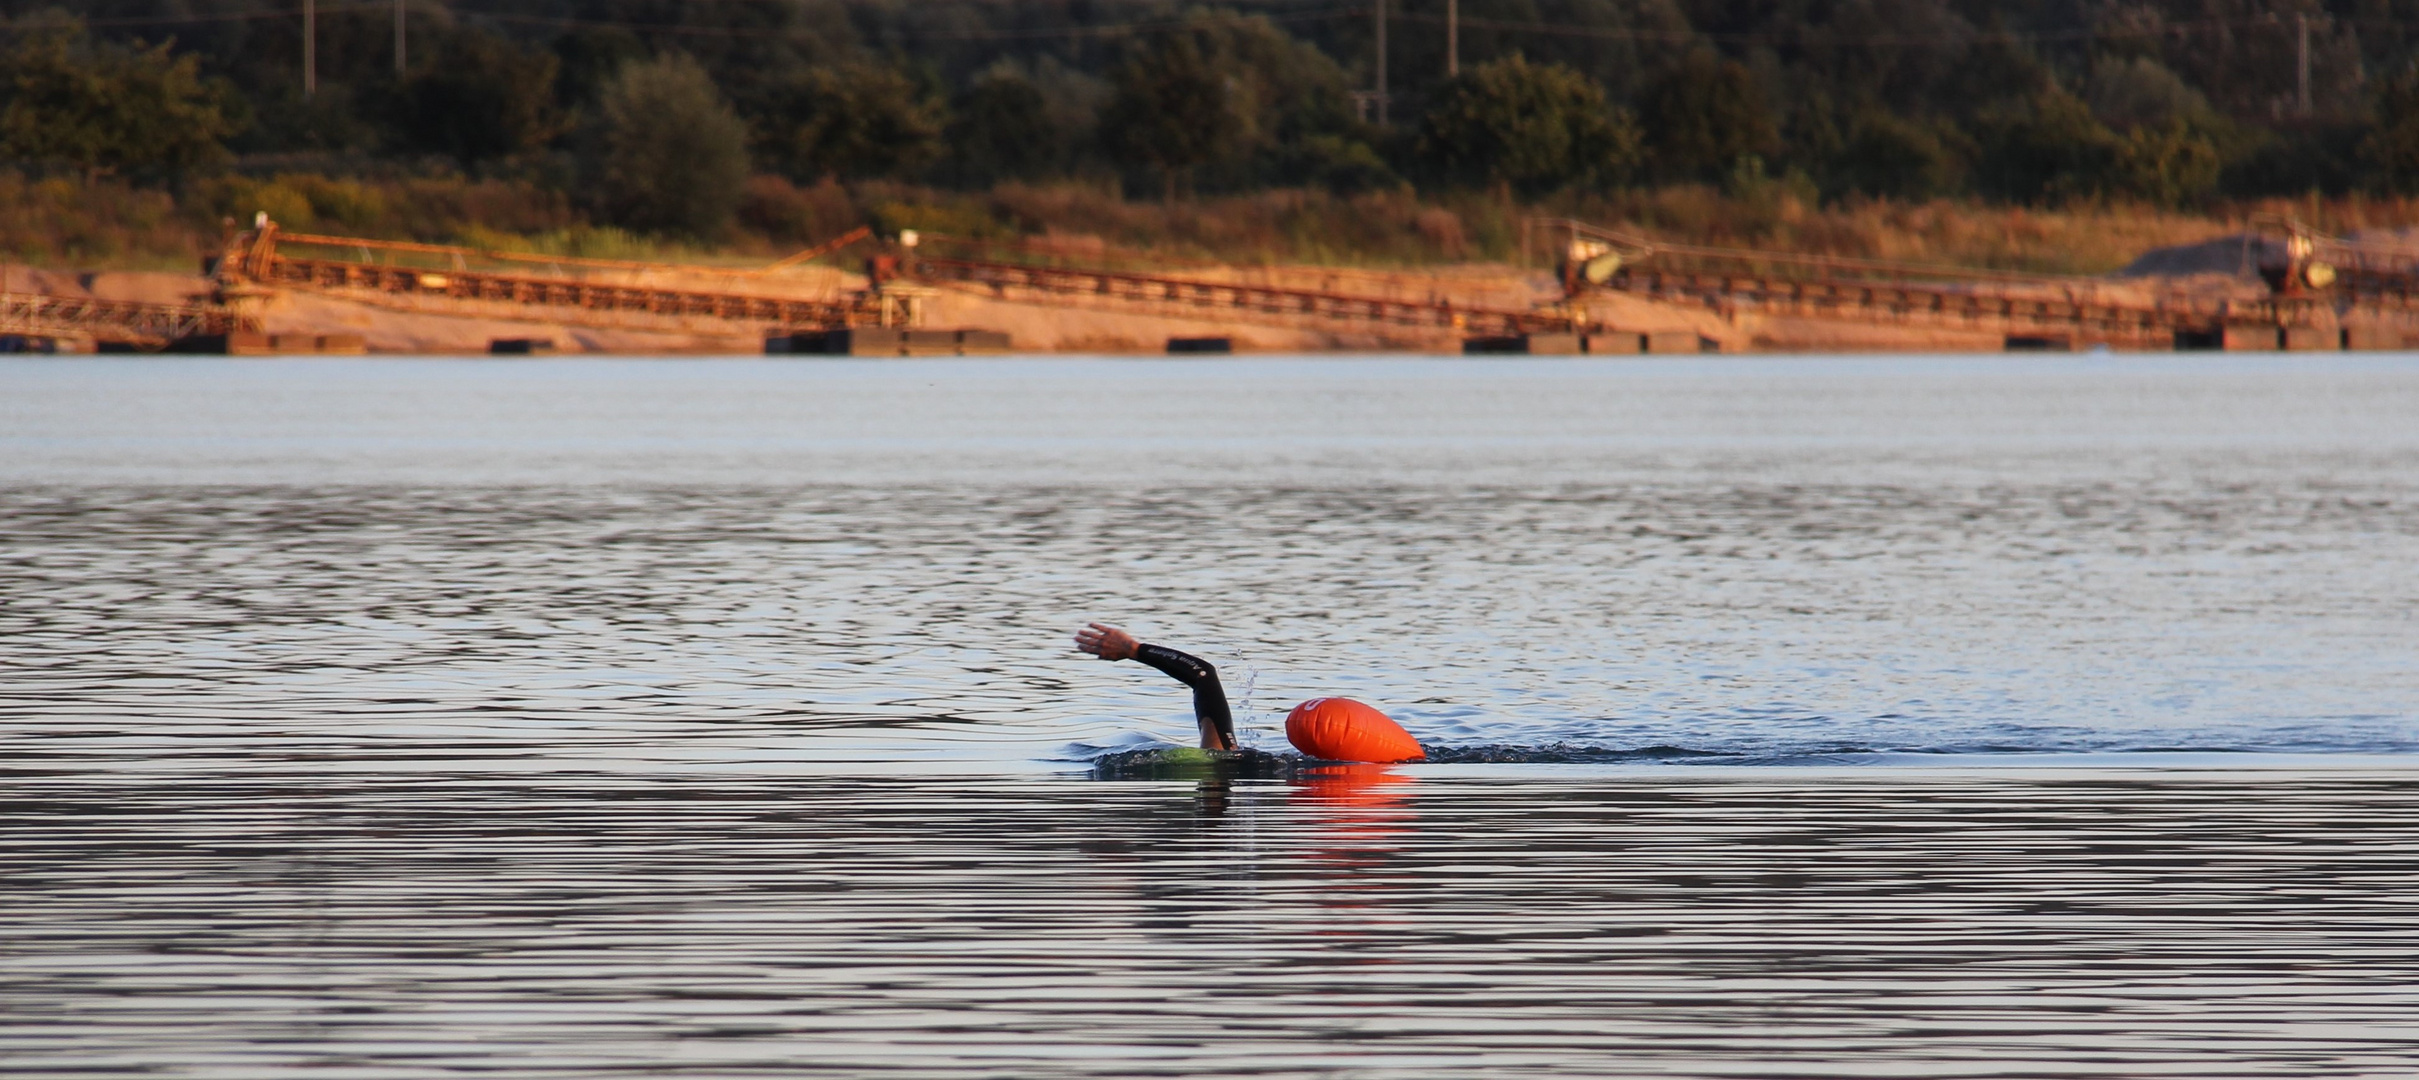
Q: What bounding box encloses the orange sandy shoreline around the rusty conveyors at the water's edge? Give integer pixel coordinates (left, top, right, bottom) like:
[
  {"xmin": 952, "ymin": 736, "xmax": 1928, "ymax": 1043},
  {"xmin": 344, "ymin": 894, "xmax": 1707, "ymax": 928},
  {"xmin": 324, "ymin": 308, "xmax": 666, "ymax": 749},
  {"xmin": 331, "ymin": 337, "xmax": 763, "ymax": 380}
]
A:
[{"xmin": 0, "ymin": 248, "xmax": 2380, "ymax": 358}]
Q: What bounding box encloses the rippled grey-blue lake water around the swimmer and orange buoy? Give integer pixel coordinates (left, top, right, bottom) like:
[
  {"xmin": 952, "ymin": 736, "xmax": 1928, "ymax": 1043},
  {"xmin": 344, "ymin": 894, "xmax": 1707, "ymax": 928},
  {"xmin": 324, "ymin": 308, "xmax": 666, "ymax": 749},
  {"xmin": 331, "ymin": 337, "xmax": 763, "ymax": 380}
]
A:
[{"xmin": 0, "ymin": 356, "xmax": 2419, "ymax": 1078}]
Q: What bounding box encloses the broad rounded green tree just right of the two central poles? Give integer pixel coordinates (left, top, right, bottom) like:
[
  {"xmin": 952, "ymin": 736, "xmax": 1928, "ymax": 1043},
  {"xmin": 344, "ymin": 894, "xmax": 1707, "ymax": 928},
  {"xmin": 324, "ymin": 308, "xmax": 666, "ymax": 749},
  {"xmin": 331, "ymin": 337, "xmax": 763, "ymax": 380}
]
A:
[{"xmin": 1415, "ymin": 53, "xmax": 1638, "ymax": 196}]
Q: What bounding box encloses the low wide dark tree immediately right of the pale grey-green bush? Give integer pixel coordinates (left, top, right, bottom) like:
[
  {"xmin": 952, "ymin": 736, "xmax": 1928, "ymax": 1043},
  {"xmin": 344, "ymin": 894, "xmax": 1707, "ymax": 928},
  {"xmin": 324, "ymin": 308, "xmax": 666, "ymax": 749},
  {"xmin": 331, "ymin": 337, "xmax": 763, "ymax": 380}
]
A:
[{"xmin": 755, "ymin": 65, "xmax": 946, "ymax": 182}]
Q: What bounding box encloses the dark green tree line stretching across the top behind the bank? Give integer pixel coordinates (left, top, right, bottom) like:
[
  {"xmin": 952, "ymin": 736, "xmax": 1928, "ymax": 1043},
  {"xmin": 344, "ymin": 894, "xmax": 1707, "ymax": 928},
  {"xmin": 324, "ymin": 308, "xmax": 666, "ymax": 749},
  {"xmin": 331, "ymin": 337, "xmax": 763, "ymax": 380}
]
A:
[{"xmin": 0, "ymin": 0, "xmax": 2419, "ymax": 237}]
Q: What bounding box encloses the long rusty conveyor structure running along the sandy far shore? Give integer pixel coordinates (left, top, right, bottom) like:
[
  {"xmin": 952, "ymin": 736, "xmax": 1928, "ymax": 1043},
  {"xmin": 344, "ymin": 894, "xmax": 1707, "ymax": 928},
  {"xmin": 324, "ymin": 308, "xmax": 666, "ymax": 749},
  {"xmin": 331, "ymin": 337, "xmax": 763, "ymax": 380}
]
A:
[{"xmin": 188, "ymin": 218, "xmax": 2419, "ymax": 349}]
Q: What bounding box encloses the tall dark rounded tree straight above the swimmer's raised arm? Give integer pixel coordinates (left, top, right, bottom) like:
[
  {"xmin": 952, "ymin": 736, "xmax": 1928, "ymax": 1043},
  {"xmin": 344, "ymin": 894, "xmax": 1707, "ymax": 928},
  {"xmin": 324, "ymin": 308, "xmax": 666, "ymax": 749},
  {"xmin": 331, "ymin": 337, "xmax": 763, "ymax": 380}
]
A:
[{"xmin": 1101, "ymin": 34, "xmax": 1246, "ymax": 203}]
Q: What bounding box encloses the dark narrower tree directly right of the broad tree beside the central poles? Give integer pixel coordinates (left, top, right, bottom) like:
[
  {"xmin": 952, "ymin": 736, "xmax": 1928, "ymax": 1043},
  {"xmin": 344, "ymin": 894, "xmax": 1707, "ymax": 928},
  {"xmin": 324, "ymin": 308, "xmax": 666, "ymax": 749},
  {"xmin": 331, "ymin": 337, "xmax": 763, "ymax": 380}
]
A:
[{"xmin": 1640, "ymin": 51, "xmax": 1780, "ymax": 179}]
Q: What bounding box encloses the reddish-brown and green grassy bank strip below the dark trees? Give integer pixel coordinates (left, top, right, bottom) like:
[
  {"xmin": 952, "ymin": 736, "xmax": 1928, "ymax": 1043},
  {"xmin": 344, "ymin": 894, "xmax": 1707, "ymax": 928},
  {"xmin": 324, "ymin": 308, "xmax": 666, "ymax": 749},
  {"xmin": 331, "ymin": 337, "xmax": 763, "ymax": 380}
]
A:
[{"xmin": 18, "ymin": 172, "xmax": 2419, "ymax": 274}]
